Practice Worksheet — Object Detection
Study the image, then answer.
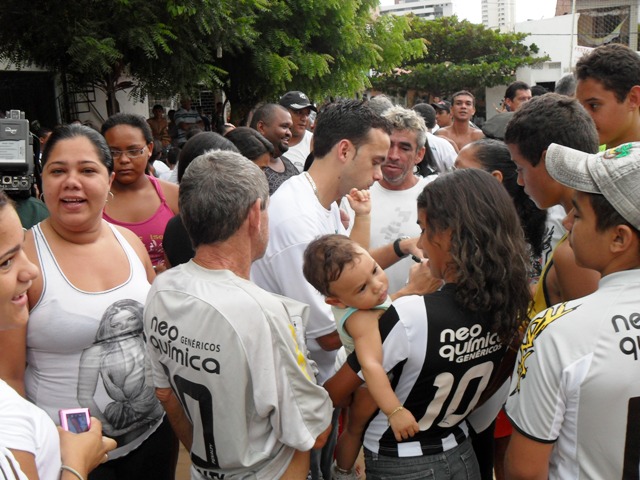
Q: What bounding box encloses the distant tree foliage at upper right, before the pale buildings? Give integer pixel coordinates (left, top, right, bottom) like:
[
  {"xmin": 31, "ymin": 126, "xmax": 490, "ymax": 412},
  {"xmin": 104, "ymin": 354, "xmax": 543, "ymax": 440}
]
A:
[{"xmin": 372, "ymin": 16, "xmax": 548, "ymax": 97}]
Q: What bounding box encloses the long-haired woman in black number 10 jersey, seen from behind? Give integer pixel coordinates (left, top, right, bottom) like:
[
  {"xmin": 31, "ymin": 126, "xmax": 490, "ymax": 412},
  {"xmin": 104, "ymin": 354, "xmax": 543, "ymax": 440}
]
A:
[{"xmin": 324, "ymin": 169, "xmax": 529, "ymax": 480}]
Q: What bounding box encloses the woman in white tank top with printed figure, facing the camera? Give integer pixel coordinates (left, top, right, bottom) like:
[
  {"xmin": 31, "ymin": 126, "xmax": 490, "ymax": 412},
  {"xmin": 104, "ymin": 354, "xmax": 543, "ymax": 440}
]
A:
[{"xmin": 0, "ymin": 125, "xmax": 177, "ymax": 480}]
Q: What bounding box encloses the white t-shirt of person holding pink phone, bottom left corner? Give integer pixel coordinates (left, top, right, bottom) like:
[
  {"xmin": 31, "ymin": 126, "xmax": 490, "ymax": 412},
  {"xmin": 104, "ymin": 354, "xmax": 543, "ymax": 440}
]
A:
[{"xmin": 0, "ymin": 380, "xmax": 61, "ymax": 480}]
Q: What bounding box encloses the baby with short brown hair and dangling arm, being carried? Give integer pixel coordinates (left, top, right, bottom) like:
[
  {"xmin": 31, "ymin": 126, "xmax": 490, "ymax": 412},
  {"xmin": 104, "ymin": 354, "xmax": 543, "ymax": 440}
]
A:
[{"xmin": 303, "ymin": 235, "xmax": 419, "ymax": 479}]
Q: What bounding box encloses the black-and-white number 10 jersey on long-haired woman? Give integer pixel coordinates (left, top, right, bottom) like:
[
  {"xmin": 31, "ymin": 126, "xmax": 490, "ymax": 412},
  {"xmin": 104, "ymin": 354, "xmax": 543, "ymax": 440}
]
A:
[{"xmin": 347, "ymin": 284, "xmax": 504, "ymax": 457}]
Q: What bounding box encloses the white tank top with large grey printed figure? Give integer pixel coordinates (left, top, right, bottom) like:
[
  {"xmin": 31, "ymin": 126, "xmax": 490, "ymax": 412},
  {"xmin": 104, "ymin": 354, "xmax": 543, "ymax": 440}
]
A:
[{"xmin": 25, "ymin": 224, "xmax": 163, "ymax": 458}]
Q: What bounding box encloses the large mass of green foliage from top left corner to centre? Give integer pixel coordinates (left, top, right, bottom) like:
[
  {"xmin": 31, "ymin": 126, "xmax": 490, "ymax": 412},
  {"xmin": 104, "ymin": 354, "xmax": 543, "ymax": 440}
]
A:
[{"xmin": 0, "ymin": 0, "xmax": 425, "ymax": 117}]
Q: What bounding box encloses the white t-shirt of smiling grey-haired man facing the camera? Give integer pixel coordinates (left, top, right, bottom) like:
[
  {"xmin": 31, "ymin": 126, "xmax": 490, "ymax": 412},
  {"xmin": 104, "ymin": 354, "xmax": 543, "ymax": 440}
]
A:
[{"xmin": 342, "ymin": 175, "xmax": 437, "ymax": 293}]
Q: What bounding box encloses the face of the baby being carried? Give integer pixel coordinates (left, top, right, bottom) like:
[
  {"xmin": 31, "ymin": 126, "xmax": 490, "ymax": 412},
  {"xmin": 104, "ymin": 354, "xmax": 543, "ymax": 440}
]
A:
[{"xmin": 327, "ymin": 247, "xmax": 389, "ymax": 310}]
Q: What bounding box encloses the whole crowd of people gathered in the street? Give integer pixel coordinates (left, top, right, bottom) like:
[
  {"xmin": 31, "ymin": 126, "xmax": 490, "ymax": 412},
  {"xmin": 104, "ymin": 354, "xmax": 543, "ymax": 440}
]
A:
[{"xmin": 0, "ymin": 44, "xmax": 640, "ymax": 480}]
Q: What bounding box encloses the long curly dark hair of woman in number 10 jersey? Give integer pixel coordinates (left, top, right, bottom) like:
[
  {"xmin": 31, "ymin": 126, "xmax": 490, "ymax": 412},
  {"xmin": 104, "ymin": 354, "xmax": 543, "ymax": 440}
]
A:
[{"xmin": 418, "ymin": 169, "xmax": 531, "ymax": 341}]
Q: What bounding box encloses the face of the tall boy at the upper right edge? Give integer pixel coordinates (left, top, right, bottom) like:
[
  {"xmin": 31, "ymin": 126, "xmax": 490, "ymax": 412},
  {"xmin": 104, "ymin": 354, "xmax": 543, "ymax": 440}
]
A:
[{"xmin": 576, "ymin": 78, "xmax": 640, "ymax": 148}]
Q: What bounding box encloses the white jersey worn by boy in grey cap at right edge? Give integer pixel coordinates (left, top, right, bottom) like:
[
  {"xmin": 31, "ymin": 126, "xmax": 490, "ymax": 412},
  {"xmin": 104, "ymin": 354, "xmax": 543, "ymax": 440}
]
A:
[{"xmin": 506, "ymin": 270, "xmax": 640, "ymax": 480}]
